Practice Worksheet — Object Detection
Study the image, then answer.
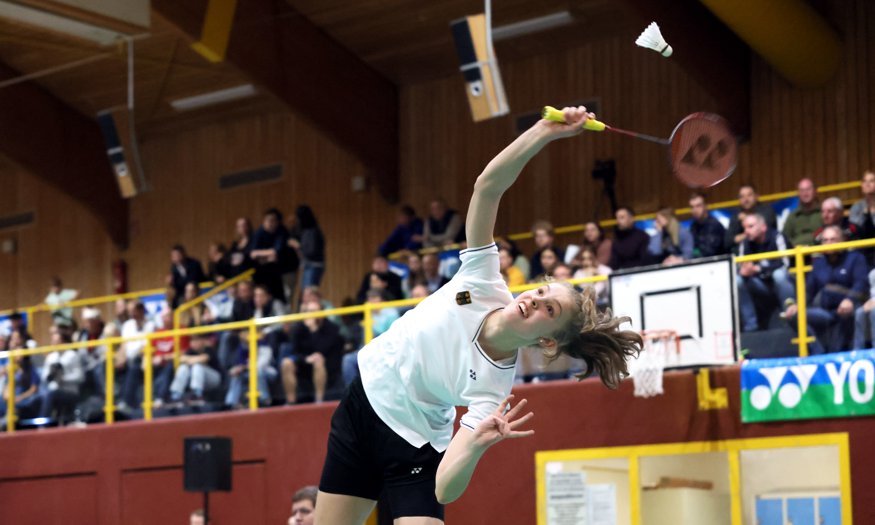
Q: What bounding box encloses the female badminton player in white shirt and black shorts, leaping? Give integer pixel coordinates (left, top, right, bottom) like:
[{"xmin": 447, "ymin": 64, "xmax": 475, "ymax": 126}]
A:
[{"xmin": 316, "ymin": 107, "xmax": 641, "ymax": 525}]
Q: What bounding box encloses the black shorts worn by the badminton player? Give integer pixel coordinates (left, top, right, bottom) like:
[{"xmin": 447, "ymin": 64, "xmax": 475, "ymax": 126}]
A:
[{"xmin": 319, "ymin": 378, "xmax": 444, "ymax": 520}]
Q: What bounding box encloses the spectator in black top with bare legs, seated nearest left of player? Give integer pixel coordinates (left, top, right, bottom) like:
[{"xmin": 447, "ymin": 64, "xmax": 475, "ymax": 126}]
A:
[{"xmin": 280, "ymin": 301, "xmax": 344, "ymax": 405}]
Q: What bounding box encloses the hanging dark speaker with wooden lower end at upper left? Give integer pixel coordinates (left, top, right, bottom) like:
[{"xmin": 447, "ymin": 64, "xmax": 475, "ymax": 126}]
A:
[{"xmin": 97, "ymin": 109, "xmax": 143, "ymax": 199}]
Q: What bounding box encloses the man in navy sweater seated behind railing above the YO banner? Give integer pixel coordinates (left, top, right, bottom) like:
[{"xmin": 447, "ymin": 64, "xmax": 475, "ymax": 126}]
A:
[{"xmin": 784, "ymin": 226, "xmax": 868, "ymax": 354}]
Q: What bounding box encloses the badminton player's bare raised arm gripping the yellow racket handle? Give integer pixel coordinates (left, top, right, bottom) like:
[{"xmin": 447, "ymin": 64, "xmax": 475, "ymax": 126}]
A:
[{"xmin": 465, "ymin": 106, "xmax": 593, "ymax": 247}]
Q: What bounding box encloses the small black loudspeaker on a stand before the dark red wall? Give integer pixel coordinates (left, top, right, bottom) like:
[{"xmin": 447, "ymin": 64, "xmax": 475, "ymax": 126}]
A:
[{"xmin": 183, "ymin": 437, "xmax": 231, "ymax": 492}]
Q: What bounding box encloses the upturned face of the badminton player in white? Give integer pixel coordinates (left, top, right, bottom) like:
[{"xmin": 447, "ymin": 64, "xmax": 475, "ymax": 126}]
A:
[{"xmin": 503, "ymin": 283, "xmax": 575, "ymax": 344}]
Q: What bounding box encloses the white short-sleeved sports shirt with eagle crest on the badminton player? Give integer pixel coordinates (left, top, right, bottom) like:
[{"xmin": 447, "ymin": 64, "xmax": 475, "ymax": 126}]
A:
[{"xmin": 358, "ymin": 244, "xmax": 516, "ymax": 452}]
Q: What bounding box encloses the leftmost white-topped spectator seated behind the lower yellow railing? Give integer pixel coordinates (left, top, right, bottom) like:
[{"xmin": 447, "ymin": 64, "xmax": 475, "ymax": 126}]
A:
[{"xmin": 39, "ymin": 327, "xmax": 85, "ymax": 420}]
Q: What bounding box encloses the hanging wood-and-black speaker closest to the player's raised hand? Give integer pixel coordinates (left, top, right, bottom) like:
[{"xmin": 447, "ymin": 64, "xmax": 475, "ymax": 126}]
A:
[{"xmin": 450, "ymin": 14, "xmax": 510, "ymax": 122}]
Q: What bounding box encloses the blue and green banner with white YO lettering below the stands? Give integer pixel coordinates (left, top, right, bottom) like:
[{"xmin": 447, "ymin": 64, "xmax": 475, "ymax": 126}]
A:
[{"xmin": 741, "ymin": 350, "xmax": 875, "ymax": 423}]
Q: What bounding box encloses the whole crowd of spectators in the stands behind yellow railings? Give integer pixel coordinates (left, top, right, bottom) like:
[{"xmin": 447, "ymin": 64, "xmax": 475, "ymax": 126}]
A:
[{"xmin": 0, "ymin": 171, "xmax": 875, "ymax": 428}]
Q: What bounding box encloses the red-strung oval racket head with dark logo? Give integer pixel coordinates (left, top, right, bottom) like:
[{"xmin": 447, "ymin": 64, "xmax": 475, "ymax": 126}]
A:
[{"xmin": 669, "ymin": 112, "xmax": 738, "ymax": 189}]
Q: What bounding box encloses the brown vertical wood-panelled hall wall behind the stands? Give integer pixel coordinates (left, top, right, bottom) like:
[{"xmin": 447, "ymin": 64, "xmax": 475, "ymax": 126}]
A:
[{"xmin": 0, "ymin": 0, "xmax": 875, "ymax": 320}]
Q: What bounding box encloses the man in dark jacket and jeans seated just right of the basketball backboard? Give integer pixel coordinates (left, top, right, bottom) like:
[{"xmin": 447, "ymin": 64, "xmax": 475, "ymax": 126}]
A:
[{"xmin": 737, "ymin": 213, "xmax": 795, "ymax": 332}]
